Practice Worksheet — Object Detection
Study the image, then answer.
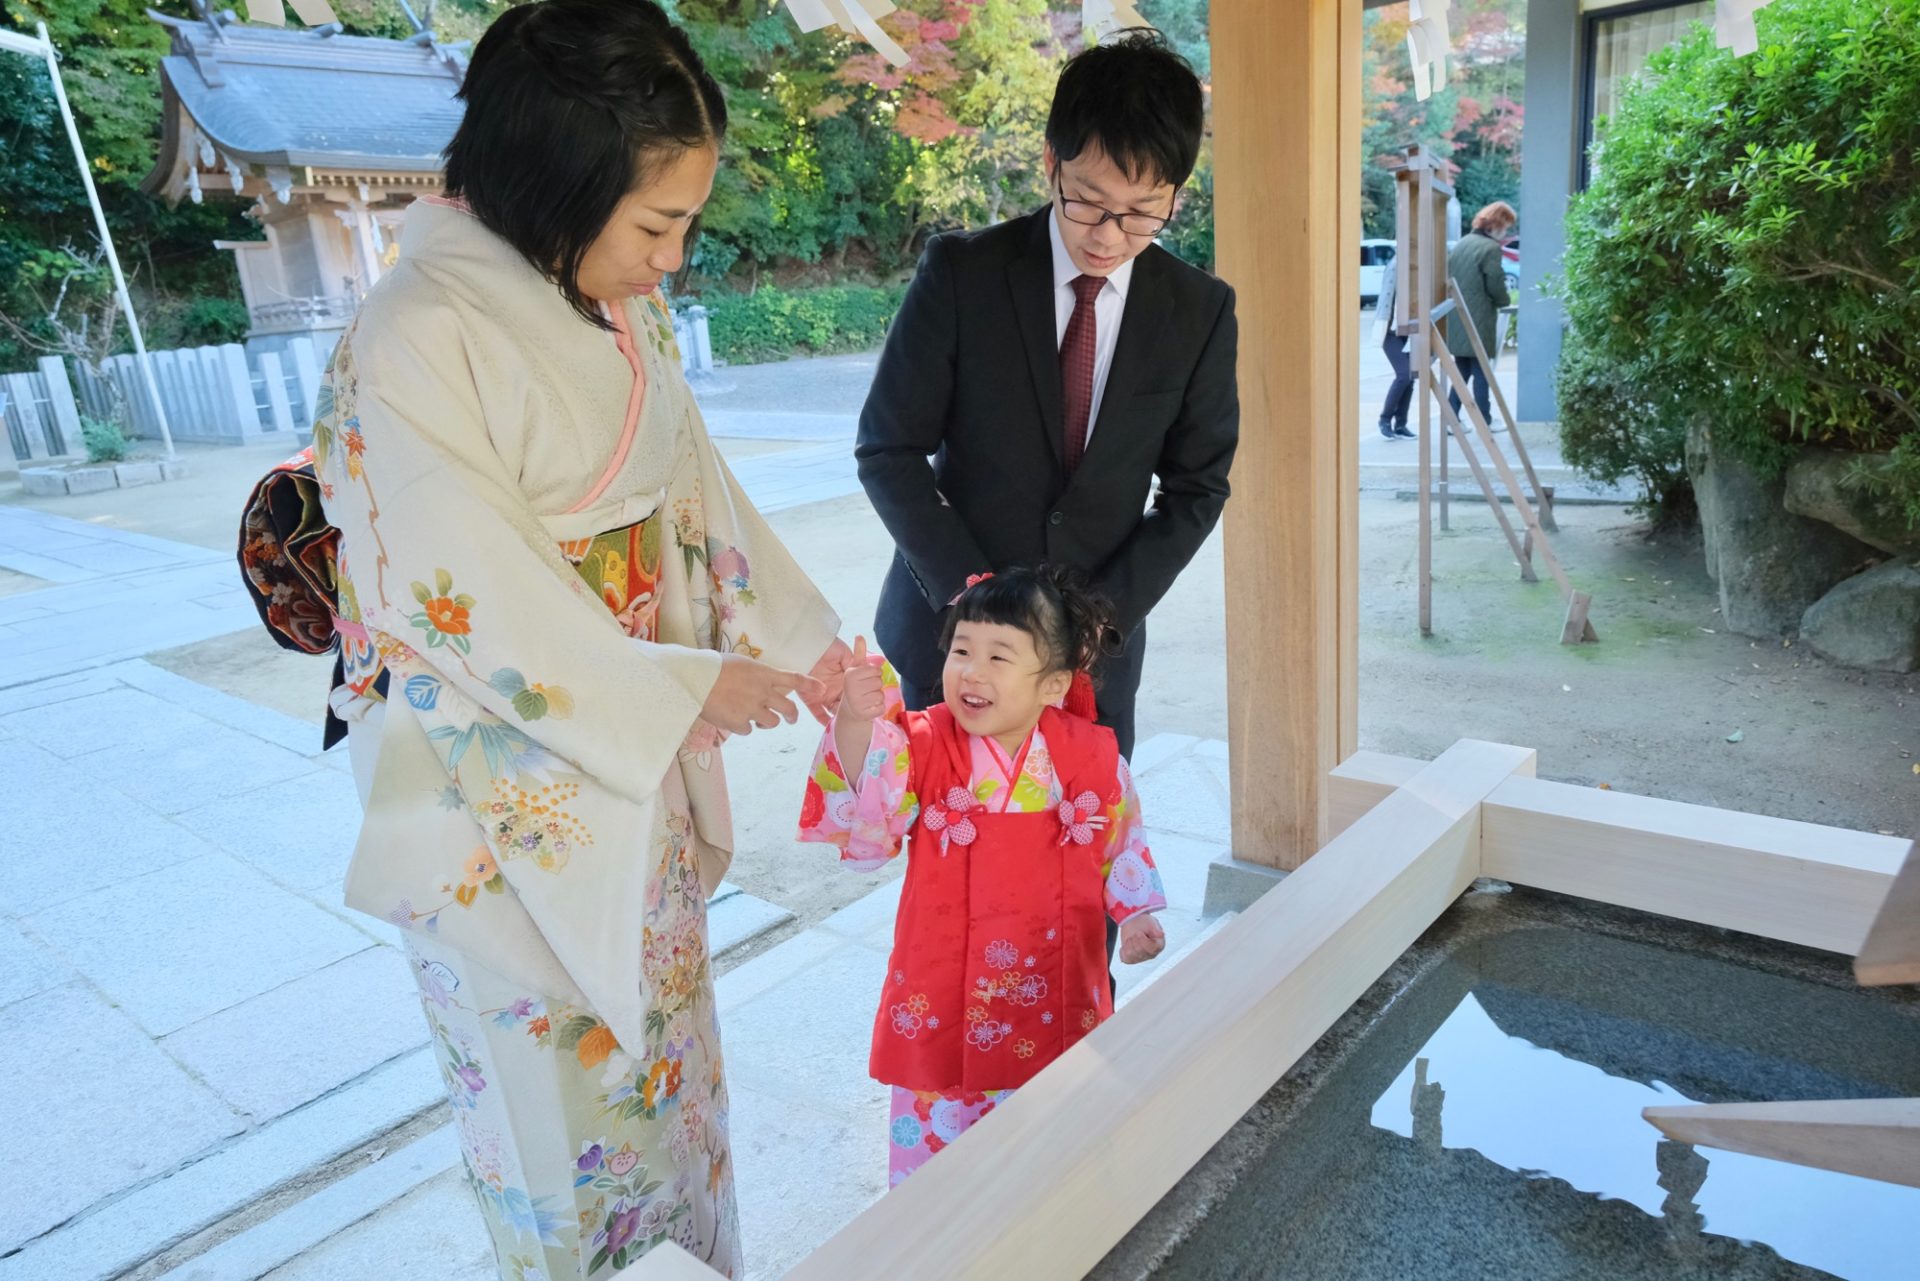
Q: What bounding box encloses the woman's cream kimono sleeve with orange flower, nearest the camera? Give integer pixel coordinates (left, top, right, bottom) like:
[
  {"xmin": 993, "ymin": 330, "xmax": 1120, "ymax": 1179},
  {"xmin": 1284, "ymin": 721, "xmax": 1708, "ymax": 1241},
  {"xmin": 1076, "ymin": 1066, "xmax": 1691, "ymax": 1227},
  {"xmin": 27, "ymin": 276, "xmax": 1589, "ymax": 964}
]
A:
[{"xmin": 315, "ymin": 307, "xmax": 720, "ymax": 801}]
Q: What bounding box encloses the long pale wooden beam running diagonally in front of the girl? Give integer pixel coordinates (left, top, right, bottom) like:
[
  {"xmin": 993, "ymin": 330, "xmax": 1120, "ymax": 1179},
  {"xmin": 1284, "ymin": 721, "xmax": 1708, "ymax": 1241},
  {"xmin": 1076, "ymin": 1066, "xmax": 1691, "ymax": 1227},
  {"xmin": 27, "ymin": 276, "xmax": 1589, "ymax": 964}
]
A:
[{"xmin": 691, "ymin": 741, "xmax": 1532, "ymax": 1281}]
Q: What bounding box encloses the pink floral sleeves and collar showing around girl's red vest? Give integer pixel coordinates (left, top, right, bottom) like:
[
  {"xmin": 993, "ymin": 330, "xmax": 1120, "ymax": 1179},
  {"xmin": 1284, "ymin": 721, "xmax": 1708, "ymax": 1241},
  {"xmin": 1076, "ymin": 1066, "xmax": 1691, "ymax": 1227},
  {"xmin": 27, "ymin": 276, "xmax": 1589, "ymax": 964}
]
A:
[{"xmin": 799, "ymin": 657, "xmax": 1167, "ymax": 922}]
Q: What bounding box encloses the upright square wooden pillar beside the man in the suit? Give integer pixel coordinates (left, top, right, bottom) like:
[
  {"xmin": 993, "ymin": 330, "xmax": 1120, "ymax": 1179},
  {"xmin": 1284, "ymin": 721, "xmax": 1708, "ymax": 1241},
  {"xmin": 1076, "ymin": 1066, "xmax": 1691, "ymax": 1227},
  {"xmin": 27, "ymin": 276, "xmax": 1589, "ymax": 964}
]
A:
[{"xmin": 1210, "ymin": 0, "xmax": 1361, "ymax": 868}]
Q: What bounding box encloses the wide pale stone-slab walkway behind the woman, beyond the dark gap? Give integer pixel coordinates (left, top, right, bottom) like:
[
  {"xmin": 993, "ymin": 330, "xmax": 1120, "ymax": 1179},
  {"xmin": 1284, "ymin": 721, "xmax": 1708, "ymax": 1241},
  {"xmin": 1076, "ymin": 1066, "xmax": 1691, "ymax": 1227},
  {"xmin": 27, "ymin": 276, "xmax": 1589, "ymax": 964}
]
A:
[{"xmin": 0, "ymin": 507, "xmax": 791, "ymax": 1281}]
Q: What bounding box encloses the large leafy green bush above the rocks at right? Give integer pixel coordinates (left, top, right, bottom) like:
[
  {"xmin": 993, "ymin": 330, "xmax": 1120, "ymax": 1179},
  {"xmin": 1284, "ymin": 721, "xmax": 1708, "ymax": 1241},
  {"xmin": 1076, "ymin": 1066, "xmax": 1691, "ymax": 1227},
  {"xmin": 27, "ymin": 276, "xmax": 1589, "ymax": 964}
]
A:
[{"xmin": 1553, "ymin": 0, "xmax": 1920, "ymax": 519}]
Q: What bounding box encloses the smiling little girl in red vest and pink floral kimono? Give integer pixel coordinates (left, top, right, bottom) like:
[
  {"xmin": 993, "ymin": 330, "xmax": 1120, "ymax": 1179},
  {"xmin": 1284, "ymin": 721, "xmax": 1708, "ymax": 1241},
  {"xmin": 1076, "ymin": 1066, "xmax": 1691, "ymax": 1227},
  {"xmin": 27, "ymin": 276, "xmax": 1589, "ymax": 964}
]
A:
[{"xmin": 801, "ymin": 568, "xmax": 1167, "ymax": 1183}]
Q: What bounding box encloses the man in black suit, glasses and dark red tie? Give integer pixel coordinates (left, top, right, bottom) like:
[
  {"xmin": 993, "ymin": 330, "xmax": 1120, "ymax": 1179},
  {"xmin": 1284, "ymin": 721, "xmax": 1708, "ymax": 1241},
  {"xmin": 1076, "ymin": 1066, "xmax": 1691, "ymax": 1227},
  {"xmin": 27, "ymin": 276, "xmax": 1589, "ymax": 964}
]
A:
[{"xmin": 856, "ymin": 33, "xmax": 1240, "ymax": 757}]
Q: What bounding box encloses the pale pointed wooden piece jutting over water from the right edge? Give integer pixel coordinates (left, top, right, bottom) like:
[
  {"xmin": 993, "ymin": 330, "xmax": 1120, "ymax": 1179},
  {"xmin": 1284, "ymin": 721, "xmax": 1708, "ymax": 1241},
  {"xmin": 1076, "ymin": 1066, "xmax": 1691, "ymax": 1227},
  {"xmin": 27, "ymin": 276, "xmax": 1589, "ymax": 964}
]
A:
[{"xmin": 1642, "ymin": 1099, "xmax": 1920, "ymax": 1187}]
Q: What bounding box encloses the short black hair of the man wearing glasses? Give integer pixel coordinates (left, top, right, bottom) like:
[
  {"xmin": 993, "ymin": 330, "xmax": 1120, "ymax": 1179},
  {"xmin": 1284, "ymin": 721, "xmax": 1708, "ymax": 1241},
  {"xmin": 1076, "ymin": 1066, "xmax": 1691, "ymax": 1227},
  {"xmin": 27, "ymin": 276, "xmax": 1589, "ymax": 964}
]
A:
[{"xmin": 1046, "ymin": 27, "xmax": 1206, "ymax": 188}]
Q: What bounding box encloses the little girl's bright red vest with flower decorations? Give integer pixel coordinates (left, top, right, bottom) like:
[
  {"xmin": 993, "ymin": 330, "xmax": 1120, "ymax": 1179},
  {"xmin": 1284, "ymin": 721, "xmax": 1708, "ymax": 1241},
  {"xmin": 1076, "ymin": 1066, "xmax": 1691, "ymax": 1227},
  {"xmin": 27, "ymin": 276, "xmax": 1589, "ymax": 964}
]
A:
[{"xmin": 870, "ymin": 705, "xmax": 1119, "ymax": 1093}]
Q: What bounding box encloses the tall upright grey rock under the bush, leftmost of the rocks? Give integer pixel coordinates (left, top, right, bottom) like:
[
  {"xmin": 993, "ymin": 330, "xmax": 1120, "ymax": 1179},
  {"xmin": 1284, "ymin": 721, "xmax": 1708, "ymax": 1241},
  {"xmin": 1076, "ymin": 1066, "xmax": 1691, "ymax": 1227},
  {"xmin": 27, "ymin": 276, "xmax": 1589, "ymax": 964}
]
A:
[{"xmin": 1686, "ymin": 424, "xmax": 1882, "ymax": 638}]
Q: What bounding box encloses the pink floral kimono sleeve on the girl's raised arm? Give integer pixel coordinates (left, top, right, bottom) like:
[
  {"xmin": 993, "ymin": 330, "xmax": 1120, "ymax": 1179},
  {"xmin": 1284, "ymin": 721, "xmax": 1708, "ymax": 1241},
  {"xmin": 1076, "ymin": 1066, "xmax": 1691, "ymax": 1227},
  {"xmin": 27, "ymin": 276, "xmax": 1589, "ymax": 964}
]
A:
[{"xmin": 799, "ymin": 655, "xmax": 920, "ymax": 872}]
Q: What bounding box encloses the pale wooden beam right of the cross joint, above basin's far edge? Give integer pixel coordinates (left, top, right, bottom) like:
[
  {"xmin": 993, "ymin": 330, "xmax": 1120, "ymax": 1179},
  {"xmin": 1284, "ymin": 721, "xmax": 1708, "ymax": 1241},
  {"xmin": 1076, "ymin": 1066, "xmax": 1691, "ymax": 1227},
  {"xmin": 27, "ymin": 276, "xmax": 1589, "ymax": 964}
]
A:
[{"xmin": 1480, "ymin": 778, "xmax": 1908, "ymax": 956}]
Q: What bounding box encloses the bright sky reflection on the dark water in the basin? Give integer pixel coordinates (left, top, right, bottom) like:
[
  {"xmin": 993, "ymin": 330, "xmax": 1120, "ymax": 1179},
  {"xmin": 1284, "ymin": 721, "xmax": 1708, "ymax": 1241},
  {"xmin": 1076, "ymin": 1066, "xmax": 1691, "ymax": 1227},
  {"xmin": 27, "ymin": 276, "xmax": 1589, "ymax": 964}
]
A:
[{"xmin": 1371, "ymin": 995, "xmax": 1920, "ymax": 1281}]
